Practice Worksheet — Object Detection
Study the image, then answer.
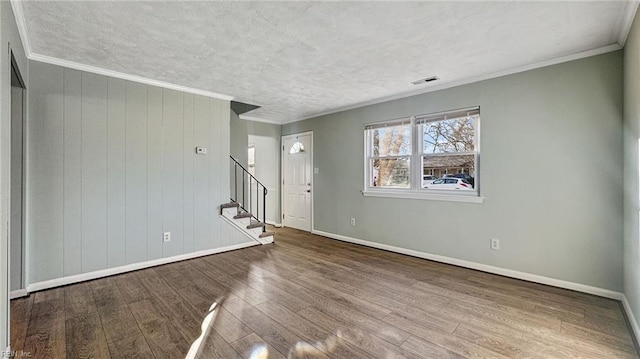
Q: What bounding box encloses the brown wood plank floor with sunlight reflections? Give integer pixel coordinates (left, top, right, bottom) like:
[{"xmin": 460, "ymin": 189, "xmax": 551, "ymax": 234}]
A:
[{"xmin": 11, "ymin": 229, "xmax": 638, "ymax": 359}]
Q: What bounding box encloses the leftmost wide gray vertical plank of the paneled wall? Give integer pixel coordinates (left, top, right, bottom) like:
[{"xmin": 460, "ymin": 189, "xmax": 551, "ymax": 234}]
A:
[{"xmin": 26, "ymin": 64, "xmax": 64, "ymax": 284}]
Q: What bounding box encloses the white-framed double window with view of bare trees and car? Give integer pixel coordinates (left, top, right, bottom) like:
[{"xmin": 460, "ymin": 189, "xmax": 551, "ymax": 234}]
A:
[{"xmin": 364, "ymin": 107, "xmax": 480, "ymax": 202}]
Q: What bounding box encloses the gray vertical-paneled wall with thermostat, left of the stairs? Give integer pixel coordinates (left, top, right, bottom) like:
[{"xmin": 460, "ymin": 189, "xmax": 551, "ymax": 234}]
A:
[{"xmin": 26, "ymin": 62, "xmax": 248, "ymax": 283}]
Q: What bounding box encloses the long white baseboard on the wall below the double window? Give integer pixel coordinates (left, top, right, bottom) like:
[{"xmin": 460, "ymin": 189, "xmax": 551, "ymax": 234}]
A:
[{"xmin": 311, "ymin": 229, "xmax": 624, "ymax": 300}]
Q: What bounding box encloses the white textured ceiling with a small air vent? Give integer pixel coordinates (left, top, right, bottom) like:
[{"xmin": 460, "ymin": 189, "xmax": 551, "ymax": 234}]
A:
[{"xmin": 14, "ymin": 1, "xmax": 635, "ymax": 123}]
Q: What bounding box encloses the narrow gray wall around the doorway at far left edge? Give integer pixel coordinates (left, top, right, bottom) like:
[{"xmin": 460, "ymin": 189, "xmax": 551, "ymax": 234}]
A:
[{"xmin": 0, "ymin": 1, "xmax": 29, "ymax": 350}]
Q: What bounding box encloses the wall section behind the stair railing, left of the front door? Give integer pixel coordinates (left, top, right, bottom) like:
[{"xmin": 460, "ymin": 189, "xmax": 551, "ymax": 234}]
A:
[{"xmin": 231, "ymin": 111, "xmax": 282, "ymax": 224}]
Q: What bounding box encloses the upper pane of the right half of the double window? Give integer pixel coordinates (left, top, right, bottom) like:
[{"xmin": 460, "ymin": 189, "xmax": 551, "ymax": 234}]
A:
[{"xmin": 422, "ymin": 115, "xmax": 479, "ymax": 155}]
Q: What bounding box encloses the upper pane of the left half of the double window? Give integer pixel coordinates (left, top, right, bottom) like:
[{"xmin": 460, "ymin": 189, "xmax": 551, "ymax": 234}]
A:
[{"xmin": 369, "ymin": 124, "xmax": 411, "ymax": 157}]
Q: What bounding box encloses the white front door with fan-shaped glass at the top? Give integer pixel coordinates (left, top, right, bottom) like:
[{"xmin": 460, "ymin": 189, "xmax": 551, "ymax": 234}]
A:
[{"xmin": 282, "ymin": 133, "xmax": 312, "ymax": 232}]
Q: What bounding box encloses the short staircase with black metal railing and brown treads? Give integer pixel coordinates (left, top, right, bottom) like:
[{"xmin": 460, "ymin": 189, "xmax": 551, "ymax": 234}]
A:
[{"xmin": 220, "ymin": 156, "xmax": 274, "ymax": 244}]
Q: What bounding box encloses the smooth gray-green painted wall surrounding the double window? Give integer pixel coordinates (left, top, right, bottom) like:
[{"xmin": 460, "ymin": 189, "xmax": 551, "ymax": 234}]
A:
[{"xmin": 282, "ymin": 51, "xmax": 624, "ymax": 291}]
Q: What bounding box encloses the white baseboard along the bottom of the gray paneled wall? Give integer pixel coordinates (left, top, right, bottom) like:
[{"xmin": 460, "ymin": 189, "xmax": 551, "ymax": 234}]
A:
[{"xmin": 26, "ymin": 241, "xmax": 260, "ymax": 293}]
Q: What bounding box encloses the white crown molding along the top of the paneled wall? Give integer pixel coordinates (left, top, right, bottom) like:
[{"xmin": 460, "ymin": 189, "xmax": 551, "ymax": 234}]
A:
[{"xmin": 28, "ymin": 53, "xmax": 233, "ymax": 101}]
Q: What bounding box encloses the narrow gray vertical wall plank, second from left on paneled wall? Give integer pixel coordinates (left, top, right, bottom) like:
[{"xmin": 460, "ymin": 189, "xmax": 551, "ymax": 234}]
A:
[{"xmin": 63, "ymin": 69, "xmax": 82, "ymax": 275}]
